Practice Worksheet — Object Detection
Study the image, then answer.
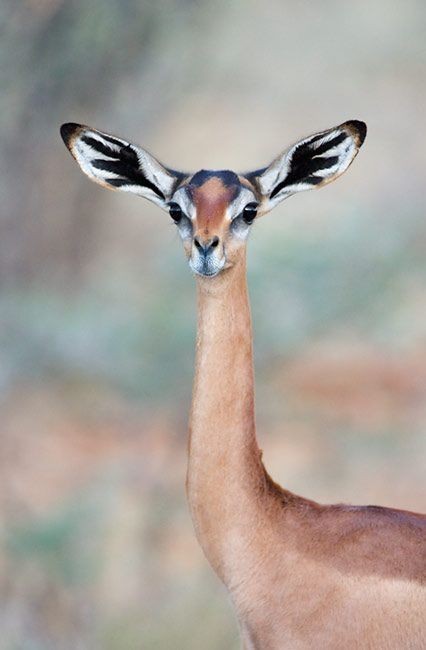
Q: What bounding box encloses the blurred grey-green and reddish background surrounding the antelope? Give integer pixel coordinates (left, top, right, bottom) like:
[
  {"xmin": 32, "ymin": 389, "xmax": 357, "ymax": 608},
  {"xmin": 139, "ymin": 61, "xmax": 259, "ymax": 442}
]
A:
[{"xmin": 0, "ymin": 0, "xmax": 426, "ymax": 650}]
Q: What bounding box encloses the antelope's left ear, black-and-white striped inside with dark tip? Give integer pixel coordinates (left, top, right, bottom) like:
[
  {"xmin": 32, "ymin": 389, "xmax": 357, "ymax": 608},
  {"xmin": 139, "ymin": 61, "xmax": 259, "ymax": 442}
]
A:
[{"xmin": 61, "ymin": 123, "xmax": 185, "ymax": 209}]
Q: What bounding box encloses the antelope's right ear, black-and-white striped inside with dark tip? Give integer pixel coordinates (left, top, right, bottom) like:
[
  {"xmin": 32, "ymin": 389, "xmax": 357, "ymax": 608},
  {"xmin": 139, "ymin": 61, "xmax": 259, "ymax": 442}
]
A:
[{"xmin": 246, "ymin": 120, "xmax": 367, "ymax": 212}]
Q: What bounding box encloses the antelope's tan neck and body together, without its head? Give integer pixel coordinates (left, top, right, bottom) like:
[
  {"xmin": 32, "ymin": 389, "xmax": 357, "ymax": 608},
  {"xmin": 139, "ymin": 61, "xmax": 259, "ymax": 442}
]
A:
[{"xmin": 187, "ymin": 247, "xmax": 426, "ymax": 650}]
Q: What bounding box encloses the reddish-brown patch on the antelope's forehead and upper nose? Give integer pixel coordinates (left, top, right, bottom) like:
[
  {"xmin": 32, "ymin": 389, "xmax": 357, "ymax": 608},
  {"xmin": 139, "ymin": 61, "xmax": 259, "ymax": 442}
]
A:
[{"xmin": 192, "ymin": 177, "xmax": 235, "ymax": 239}]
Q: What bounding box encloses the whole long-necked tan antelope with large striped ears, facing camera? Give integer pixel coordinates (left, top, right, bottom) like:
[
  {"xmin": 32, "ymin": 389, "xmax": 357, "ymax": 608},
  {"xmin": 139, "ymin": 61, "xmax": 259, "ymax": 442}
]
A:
[{"xmin": 61, "ymin": 120, "xmax": 426, "ymax": 650}]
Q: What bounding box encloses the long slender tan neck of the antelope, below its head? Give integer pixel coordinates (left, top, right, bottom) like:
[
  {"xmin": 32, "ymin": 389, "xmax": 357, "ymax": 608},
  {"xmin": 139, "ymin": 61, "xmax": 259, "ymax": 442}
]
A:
[{"xmin": 187, "ymin": 255, "xmax": 266, "ymax": 577}]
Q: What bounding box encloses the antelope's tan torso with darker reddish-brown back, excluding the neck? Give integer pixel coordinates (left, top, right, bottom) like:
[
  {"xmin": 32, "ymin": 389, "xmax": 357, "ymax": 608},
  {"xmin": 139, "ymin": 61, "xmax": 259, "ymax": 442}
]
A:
[{"xmin": 235, "ymin": 486, "xmax": 426, "ymax": 650}]
